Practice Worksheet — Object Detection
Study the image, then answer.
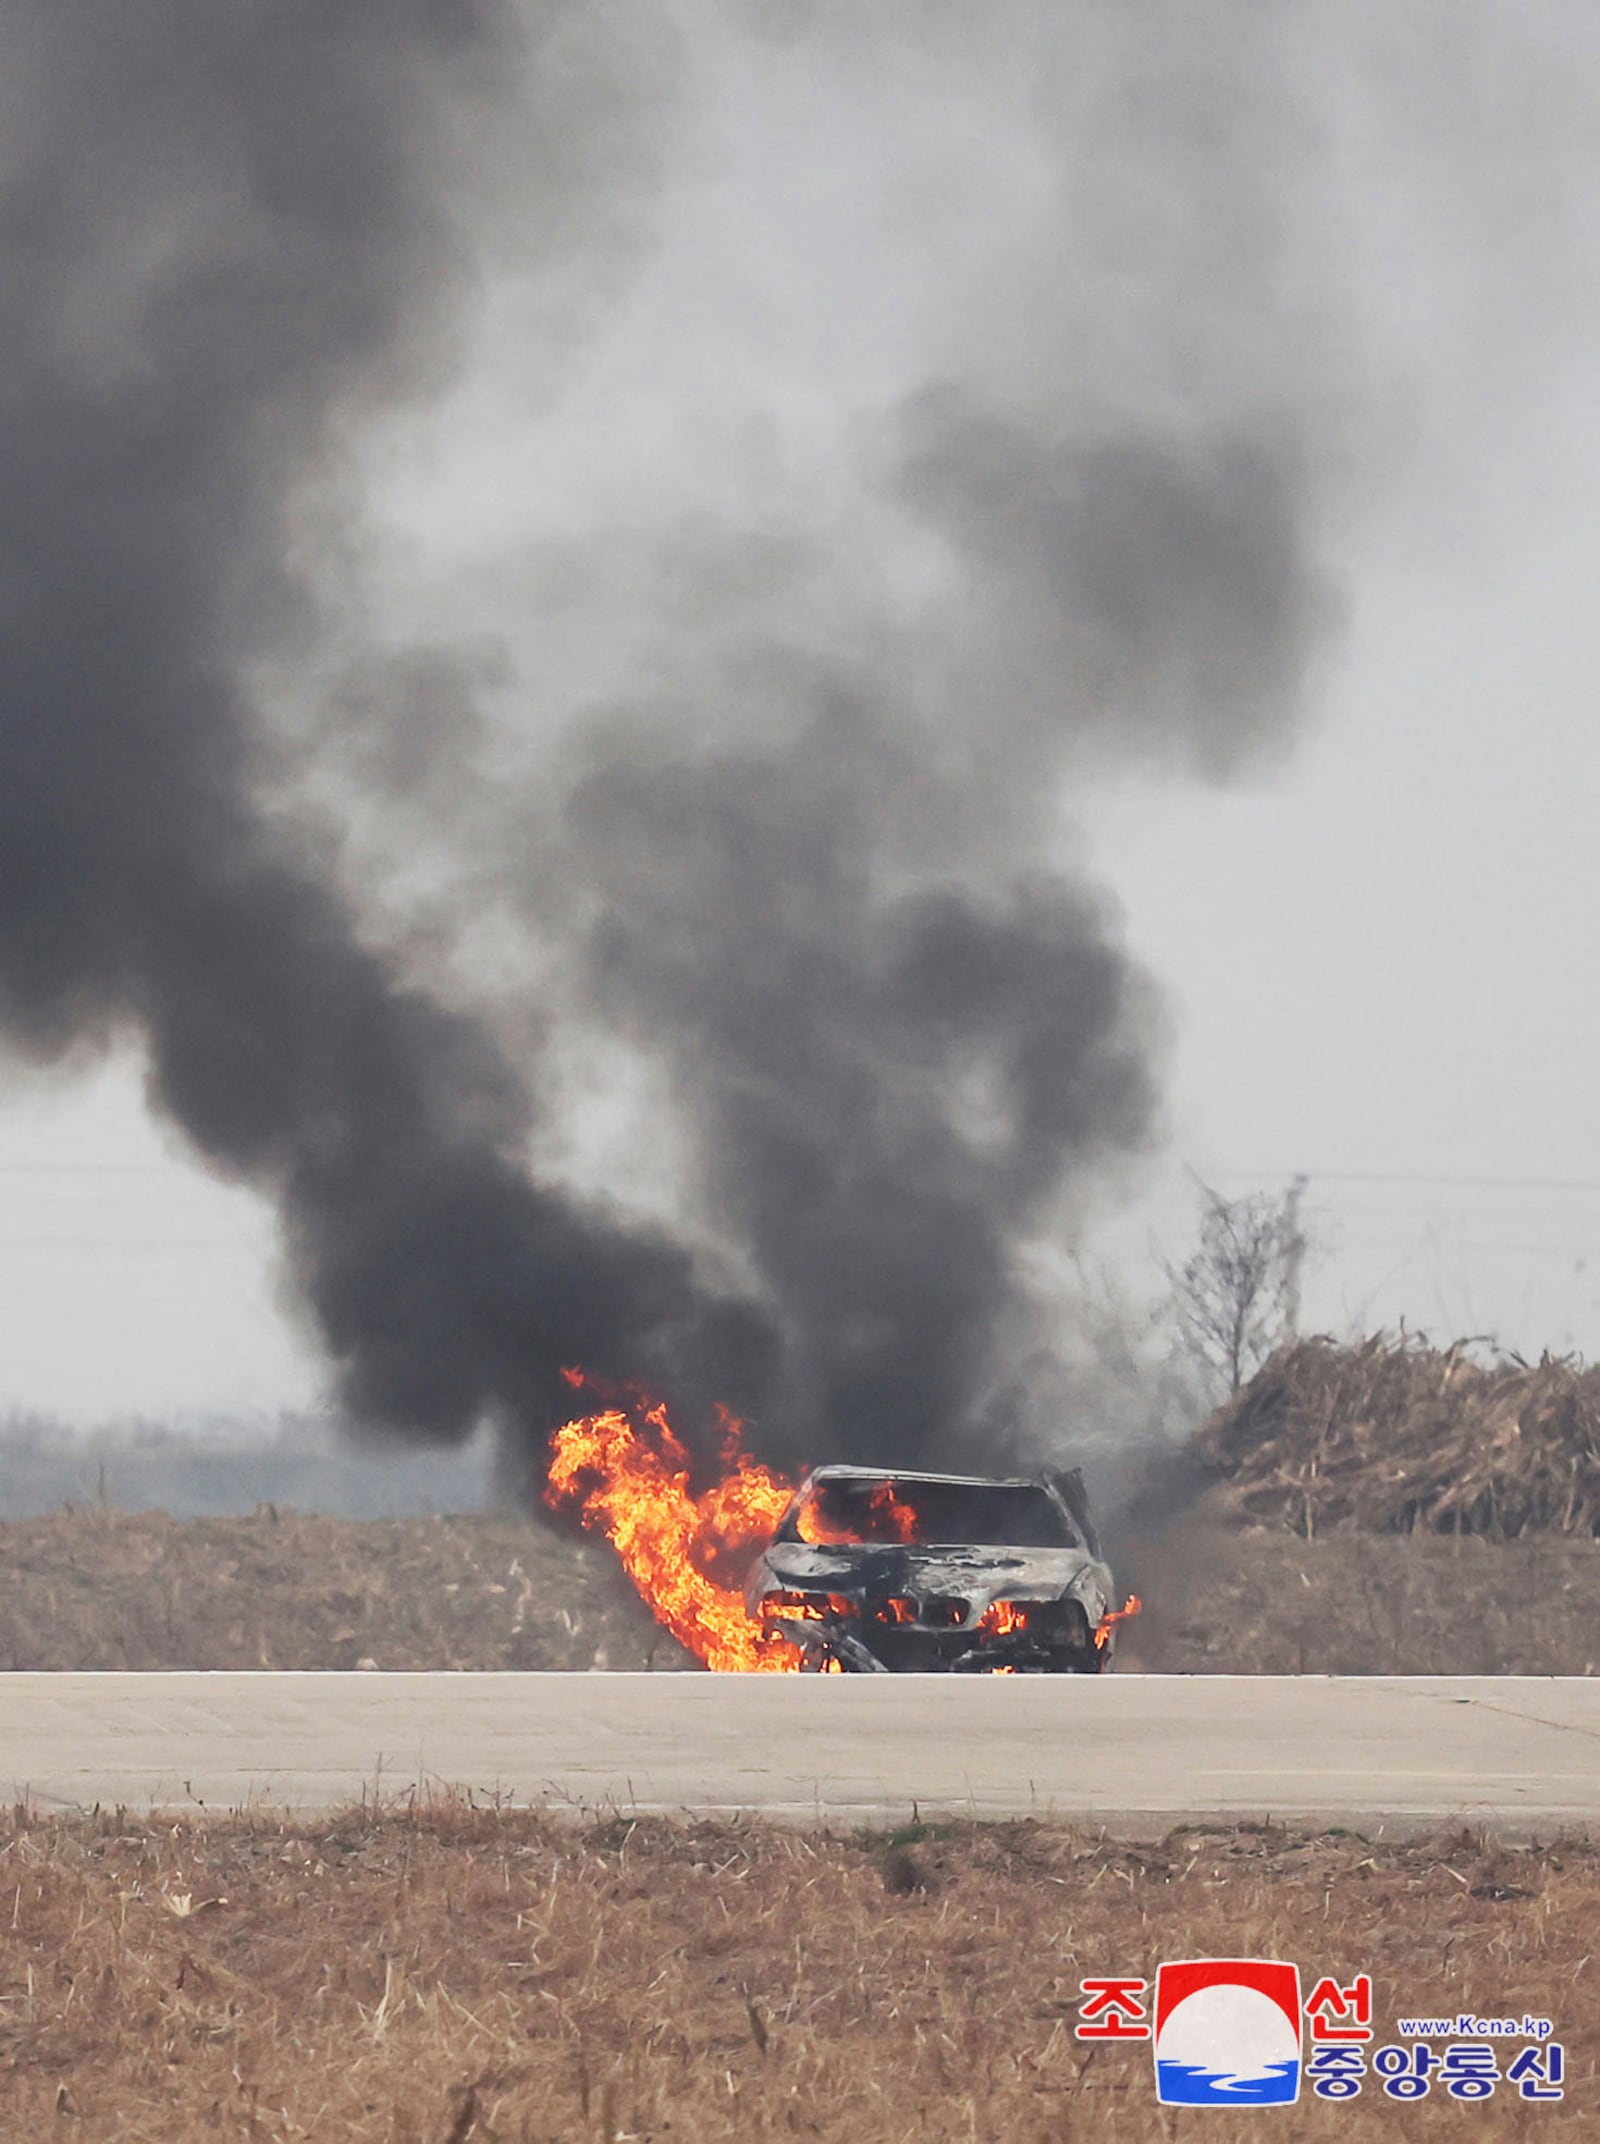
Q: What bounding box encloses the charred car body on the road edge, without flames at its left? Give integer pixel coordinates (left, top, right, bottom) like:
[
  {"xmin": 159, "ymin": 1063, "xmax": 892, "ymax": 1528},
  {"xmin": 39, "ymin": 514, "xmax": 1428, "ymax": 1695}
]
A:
[{"xmin": 744, "ymin": 1466, "xmax": 1111, "ymax": 1674}]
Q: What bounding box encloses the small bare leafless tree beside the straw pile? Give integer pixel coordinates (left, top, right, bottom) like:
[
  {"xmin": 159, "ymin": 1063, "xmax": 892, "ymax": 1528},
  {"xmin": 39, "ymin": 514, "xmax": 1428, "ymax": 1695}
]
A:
[{"xmin": 1165, "ymin": 1177, "xmax": 1308, "ymax": 1391}]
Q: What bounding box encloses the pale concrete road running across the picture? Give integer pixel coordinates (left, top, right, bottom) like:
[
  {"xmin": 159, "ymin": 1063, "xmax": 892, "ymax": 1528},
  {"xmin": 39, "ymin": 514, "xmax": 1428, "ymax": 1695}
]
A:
[{"xmin": 0, "ymin": 1674, "xmax": 1600, "ymax": 1837}]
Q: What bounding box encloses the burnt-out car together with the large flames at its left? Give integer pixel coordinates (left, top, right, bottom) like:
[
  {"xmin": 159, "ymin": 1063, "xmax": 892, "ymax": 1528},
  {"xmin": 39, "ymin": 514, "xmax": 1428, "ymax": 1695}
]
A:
[{"xmin": 545, "ymin": 1368, "xmax": 1139, "ymax": 1674}]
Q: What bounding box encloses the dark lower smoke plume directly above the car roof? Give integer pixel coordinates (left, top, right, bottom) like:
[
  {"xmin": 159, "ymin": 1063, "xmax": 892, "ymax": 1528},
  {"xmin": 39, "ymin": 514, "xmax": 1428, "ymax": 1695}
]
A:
[{"xmin": 566, "ymin": 716, "xmax": 1154, "ymax": 1464}]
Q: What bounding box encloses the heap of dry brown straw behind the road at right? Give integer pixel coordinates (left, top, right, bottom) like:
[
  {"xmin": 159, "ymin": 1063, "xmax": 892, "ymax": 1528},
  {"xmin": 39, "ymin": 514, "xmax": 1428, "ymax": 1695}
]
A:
[{"xmin": 1192, "ymin": 1334, "xmax": 1600, "ymax": 1539}]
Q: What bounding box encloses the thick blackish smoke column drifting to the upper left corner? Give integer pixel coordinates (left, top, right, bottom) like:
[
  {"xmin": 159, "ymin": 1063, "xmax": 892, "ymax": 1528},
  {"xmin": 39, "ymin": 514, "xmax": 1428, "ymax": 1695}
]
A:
[{"xmin": 0, "ymin": 0, "xmax": 770, "ymax": 1436}]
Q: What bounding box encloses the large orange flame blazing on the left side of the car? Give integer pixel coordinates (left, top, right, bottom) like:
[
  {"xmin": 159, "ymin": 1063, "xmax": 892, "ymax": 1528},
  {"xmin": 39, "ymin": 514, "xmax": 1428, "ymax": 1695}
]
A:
[{"xmin": 545, "ymin": 1370, "xmax": 800, "ymax": 1674}]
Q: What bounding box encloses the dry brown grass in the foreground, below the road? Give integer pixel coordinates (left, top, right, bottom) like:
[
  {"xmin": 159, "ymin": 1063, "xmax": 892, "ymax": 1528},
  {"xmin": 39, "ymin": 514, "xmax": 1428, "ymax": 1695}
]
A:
[{"xmin": 0, "ymin": 1805, "xmax": 1600, "ymax": 2144}]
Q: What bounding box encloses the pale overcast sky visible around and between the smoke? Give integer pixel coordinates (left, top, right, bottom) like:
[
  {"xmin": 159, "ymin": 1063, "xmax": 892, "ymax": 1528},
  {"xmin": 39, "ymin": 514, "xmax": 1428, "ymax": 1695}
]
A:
[{"xmin": 0, "ymin": 12, "xmax": 1600, "ymax": 1419}]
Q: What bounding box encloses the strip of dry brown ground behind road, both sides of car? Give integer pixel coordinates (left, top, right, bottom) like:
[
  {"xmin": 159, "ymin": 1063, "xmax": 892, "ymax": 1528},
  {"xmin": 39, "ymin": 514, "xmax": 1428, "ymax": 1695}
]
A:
[{"xmin": 0, "ymin": 1507, "xmax": 1600, "ymax": 1674}]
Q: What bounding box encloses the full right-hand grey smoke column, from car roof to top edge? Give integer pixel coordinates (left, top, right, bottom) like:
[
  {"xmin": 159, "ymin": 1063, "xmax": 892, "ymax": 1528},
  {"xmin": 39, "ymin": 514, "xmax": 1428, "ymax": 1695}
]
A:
[{"xmin": 489, "ymin": 6, "xmax": 1343, "ymax": 1462}]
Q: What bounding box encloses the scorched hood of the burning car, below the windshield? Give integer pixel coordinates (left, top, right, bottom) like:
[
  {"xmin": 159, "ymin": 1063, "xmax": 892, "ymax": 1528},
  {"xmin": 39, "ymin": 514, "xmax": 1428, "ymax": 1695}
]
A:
[{"xmin": 749, "ymin": 1542, "xmax": 1109, "ymax": 1621}]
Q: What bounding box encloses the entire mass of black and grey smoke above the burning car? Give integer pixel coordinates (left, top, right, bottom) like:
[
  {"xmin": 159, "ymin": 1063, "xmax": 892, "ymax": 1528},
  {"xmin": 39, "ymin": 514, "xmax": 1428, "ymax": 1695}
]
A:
[{"xmin": 0, "ymin": 0, "xmax": 1587, "ymax": 1462}]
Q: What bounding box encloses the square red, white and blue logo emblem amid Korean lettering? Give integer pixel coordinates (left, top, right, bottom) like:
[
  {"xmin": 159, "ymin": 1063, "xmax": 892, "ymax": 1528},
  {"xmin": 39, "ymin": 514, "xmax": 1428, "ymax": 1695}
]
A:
[{"xmin": 1154, "ymin": 1957, "xmax": 1300, "ymax": 2108}]
